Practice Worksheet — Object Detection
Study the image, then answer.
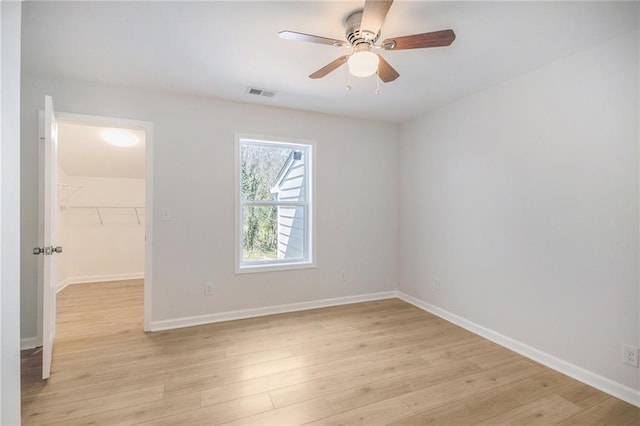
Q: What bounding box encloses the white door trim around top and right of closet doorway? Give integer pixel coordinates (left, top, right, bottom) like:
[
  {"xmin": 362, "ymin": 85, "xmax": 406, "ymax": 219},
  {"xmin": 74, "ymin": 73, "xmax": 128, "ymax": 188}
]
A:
[{"xmin": 38, "ymin": 112, "xmax": 153, "ymax": 332}]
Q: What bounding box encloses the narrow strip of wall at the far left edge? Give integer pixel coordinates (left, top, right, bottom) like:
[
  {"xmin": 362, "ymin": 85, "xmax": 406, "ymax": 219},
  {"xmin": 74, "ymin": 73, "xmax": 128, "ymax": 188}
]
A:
[{"xmin": 0, "ymin": 1, "xmax": 24, "ymax": 425}]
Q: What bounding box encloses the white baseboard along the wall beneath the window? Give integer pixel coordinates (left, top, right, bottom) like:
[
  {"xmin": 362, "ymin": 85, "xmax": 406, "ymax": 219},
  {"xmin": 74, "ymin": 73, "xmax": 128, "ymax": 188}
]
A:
[{"xmin": 149, "ymin": 291, "xmax": 397, "ymax": 331}]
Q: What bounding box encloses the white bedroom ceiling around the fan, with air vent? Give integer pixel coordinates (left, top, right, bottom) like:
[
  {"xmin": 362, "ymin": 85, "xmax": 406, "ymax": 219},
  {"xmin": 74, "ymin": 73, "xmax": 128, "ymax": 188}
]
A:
[{"xmin": 22, "ymin": 0, "xmax": 639, "ymax": 122}]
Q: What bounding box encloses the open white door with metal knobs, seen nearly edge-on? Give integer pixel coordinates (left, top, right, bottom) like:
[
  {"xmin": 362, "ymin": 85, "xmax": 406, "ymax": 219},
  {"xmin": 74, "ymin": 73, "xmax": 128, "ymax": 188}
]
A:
[{"xmin": 40, "ymin": 96, "xmax": 62, "ymax": 379}]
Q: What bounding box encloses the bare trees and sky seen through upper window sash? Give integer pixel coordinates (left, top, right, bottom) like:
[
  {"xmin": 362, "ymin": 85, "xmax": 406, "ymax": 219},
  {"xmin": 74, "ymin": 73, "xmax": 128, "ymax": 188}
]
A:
[{"xmin": 240, "ymin": 143, "xmax": 300, "ymax": 201}]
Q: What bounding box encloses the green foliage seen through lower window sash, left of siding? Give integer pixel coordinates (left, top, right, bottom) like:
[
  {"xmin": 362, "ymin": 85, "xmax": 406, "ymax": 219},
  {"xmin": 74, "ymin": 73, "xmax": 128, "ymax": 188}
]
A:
[{"xmin": 242, "ymin": 206, "xmax": 278, "ymax": 262}]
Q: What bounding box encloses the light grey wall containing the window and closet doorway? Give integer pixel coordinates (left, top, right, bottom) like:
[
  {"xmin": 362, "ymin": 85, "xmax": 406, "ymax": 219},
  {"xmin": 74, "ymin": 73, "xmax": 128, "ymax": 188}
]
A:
[{"xmin": 22, "ymin": 75, "xmax": 397, "ymax": 337}]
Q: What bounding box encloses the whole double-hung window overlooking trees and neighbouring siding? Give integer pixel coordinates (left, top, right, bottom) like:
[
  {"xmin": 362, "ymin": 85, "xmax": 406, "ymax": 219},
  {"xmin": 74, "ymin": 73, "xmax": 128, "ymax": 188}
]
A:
[{"xmin": 236, "ymin": 136, "xmax": 313, "ymax": 272}]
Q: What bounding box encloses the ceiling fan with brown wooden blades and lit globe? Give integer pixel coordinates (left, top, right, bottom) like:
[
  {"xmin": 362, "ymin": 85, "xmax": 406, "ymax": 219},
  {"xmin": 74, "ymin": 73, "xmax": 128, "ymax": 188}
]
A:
[{"xmin": 278, "ymin": 0, "xmax": 456, "ymax": 83}]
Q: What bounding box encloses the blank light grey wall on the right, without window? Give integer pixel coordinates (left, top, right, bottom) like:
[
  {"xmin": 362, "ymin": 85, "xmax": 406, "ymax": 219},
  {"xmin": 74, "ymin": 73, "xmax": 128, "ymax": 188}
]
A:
[{"xmin": 399, "ymin": 33, "xmax": 640, "ymax": 403}]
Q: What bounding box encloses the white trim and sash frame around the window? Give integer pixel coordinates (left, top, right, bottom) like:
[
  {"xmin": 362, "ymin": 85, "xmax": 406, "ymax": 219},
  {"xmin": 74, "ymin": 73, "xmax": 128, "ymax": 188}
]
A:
[{"xmin": 233, "ymin": 133, "xmax": 317, "ymax": 274}]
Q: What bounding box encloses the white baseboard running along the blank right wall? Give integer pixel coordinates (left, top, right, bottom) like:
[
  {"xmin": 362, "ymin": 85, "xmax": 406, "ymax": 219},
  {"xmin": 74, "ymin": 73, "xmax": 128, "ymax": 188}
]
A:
[{"xmin": 397, "ymin": 291, "xmax": 640, "ymax": 407}]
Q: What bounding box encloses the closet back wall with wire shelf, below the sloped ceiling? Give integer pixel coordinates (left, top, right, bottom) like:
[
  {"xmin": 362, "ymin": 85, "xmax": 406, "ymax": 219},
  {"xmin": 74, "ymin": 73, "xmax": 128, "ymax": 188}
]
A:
[{"xmin": 58, "ymin": 173, "xmax": 145, "ymax": 288}]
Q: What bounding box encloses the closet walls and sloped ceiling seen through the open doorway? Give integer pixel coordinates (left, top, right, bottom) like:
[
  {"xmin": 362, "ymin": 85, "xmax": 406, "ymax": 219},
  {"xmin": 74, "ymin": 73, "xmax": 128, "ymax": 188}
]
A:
[{"xmin": 57, "ymin": 122, "xmax": 145, "ymax": 290}]
